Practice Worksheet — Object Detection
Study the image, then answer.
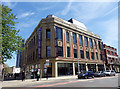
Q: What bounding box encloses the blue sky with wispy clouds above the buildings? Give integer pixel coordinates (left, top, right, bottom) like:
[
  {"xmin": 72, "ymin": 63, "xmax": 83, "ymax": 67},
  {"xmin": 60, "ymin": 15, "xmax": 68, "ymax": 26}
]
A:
[{"xmin": 3, "ymin": 2, "xmax": 118, "ymax": 66}]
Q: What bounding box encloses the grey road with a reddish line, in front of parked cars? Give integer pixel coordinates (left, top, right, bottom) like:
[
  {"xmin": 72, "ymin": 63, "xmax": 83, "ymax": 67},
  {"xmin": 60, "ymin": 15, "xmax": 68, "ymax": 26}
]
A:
[{"xmin": 3, "ymin": 75, "xmax": 118, "ymax": 89}]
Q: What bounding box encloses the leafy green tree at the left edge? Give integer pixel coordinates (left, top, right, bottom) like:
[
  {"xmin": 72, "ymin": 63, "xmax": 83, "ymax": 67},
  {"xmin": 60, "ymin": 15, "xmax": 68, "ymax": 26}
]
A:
[{"xmin": 1, "ymin": 5, "xmax": 23, "ymax": 62}]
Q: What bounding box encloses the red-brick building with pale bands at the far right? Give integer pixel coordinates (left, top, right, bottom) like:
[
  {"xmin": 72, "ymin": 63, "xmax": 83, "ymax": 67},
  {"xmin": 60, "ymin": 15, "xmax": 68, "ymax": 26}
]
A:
[{"xmin": 103, "ymin": 44, "xmax": 120, "ymax": 72}]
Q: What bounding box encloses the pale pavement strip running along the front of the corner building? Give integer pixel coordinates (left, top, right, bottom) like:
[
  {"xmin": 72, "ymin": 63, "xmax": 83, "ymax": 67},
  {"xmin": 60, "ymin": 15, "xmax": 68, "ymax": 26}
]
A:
[{"xmin": 0, "ymin": 76, "xmax": 77, "ymax": 87}]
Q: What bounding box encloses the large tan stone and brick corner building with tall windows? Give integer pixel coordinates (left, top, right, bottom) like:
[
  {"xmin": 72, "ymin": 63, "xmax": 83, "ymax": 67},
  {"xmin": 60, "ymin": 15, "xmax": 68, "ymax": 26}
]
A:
[{"xmin": 21, "ymin": 15, "xmax": 105, "ymax": 77}]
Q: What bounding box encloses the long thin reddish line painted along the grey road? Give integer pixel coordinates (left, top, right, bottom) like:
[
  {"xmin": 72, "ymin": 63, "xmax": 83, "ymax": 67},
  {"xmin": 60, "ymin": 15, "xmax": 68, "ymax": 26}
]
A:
[{"xmin": 36, "ymin": 76, "xmax": 118, "ymax": 87}]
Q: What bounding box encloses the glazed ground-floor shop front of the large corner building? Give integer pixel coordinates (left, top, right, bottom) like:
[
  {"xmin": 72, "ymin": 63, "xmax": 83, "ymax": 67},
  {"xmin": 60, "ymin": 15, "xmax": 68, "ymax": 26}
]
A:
[{"xmin": 25, "ymin": 61, "xmax": 105, "ymax": 77}]
